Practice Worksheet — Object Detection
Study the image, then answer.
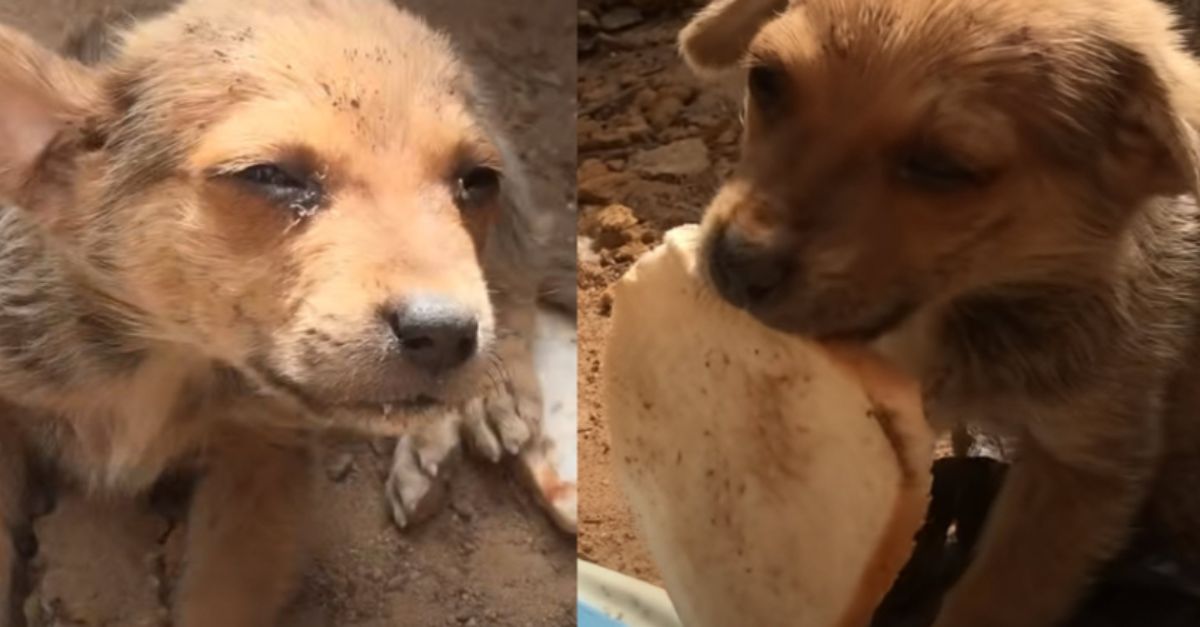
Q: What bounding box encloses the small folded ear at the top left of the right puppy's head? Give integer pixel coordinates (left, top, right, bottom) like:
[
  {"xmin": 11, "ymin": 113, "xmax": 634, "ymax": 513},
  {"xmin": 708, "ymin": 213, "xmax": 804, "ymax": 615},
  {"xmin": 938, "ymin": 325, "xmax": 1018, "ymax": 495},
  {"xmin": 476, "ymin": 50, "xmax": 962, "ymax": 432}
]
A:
[{"xmin": 679, "ymin": 0, "xmax": 790, "ymax": 73}]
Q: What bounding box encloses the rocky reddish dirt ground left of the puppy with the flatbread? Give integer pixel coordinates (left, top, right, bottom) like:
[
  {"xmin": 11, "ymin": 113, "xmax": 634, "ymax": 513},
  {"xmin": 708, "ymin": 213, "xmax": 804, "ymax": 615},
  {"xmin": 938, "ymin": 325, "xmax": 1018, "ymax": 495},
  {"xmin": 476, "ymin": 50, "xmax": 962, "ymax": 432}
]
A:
[{"xmin": 577, "ymin": 0, "xmax": 739, "ymax": 583}]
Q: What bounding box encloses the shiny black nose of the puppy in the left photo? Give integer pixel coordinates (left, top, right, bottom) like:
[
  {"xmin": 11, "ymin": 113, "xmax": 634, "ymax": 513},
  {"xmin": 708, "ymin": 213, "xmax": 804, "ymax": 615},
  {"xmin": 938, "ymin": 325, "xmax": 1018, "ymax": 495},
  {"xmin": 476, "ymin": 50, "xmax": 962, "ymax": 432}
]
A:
[{"xmin": 388, "ymin": 295, "xmax": 479, "ymax": 371}]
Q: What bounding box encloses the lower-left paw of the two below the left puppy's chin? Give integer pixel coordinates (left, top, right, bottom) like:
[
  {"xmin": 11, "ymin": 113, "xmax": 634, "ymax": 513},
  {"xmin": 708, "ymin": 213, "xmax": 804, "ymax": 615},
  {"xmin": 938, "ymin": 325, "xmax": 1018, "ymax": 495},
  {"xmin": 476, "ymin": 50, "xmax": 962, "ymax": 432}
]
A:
[{"xmin": 386, "ymin": 410, "xmax": 462, "ymax": 529}]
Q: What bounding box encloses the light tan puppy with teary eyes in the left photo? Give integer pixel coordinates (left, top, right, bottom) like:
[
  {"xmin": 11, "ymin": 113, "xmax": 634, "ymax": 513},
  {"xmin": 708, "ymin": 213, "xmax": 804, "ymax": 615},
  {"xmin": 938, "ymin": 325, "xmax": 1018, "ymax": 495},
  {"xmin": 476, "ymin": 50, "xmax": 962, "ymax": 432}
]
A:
[{"xmin": 0, "ymin": 0, "xmax": 549, "ymax": 627}]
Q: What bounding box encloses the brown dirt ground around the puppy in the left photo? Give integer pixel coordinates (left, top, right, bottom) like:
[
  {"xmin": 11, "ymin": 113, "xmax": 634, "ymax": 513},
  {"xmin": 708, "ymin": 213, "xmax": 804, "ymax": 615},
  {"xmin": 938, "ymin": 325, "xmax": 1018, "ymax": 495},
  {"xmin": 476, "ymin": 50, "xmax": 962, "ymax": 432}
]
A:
[{"xmin": 0, "ymin": 0, "xmax": 576, "ymax": 627}]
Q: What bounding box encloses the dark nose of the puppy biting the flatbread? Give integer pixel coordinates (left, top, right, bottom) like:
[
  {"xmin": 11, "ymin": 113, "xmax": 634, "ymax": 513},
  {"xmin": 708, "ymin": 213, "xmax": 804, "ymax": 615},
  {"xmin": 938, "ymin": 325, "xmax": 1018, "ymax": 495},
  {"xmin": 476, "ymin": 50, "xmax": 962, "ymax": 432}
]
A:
[{"xmin": 708, "ymin": 228, "xmax": 791, "ymax": 307}]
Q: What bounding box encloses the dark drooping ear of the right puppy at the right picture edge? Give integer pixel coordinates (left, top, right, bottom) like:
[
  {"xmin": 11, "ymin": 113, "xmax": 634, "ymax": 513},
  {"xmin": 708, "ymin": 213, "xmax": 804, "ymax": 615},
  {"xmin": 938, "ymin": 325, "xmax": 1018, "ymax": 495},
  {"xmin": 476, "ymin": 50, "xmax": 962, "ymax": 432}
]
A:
[{"xmin": 1103, "ymin": 47, "xmax": 1200, "ymax": 199}]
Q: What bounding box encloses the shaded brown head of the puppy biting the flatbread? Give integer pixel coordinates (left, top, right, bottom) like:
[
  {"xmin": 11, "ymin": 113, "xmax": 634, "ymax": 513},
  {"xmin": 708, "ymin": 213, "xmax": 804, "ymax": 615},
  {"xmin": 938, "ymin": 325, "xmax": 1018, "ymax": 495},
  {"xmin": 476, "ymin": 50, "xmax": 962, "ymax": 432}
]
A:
[{"xmin": 682, "ymin": 0, "xmax": 1196, "ymax": 339}]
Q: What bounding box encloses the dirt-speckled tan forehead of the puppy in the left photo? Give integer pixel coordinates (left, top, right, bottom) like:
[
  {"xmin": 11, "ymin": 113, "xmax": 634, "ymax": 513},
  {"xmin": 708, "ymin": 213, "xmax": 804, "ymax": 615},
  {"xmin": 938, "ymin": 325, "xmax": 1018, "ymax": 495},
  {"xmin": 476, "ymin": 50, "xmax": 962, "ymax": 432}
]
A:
[{"xmin": 112, "ymin": 0, "xmax": 478, "ymax": 160}]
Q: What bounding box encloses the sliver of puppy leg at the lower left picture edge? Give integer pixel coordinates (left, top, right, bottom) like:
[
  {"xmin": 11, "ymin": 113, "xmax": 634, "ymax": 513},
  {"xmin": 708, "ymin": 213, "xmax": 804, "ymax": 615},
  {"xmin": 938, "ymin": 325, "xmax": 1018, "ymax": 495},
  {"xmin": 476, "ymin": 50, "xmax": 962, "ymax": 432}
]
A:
[{"xmin": 0, "ymin": 416, "xmax": 28, "ymax": 627}]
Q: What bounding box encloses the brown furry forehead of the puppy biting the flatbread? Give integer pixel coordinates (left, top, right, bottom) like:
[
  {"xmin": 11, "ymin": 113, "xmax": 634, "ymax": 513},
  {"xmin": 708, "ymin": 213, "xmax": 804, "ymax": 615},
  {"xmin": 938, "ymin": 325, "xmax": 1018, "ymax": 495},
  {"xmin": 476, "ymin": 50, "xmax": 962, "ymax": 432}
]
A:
[{"xmin": 749, "ymin": 0, "xmax": 1162, "ymax": 156}]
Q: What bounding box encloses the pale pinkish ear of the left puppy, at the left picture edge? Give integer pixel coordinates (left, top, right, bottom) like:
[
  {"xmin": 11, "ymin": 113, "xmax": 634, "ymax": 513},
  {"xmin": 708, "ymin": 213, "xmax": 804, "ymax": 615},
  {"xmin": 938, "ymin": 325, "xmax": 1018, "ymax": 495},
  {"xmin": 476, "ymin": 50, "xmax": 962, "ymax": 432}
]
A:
[{"xmin": 0, "ymin": 26, "xmax": 100, "ymax": 202}]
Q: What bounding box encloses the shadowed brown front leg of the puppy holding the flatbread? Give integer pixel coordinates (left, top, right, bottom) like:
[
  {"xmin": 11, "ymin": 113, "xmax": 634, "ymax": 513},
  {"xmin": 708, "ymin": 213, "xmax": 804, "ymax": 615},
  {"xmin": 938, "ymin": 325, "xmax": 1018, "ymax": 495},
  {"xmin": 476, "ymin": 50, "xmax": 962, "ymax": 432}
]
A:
[{"xmin": 935, "ymin": 404, "xmax": 1159, "ymax": 627}]
